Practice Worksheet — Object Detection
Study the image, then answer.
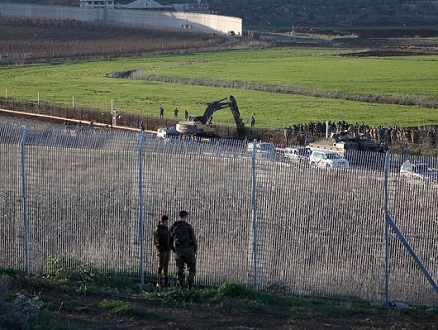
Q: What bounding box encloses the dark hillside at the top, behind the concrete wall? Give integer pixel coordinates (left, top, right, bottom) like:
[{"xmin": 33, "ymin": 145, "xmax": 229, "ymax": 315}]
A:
[{"xmin": 5, "ymin": 0, "xmax": 438, "ymax": 28}]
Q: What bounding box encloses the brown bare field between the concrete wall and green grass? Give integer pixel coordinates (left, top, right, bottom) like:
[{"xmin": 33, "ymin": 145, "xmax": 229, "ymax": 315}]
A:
[{"xmin": 0, "ymin": 16, "xmax": 438, "ymax": 65}]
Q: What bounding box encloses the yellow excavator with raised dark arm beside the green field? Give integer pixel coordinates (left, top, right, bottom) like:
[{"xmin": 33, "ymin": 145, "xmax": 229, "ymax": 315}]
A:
[{"xmin": 176, "ymin": 95, "xmax": 246, "ymax": 139}]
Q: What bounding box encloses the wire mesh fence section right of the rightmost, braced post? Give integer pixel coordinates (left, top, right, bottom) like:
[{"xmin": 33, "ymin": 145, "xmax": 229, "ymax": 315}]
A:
[{"xmin": 388, "ymin": 155, "xmax": 438, "ymax": 305}]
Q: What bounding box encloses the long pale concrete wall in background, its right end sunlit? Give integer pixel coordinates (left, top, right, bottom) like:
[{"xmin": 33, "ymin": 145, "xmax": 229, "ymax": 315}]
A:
[{"xmin": 0, "ymin": 3, "xmax": 242, "ymax": 35}]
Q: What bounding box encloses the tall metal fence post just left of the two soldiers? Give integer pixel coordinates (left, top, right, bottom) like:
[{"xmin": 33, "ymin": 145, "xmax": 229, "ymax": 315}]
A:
[{"xmin": 138, "ymin": 132, "xmax": 146, "ymax": 285}]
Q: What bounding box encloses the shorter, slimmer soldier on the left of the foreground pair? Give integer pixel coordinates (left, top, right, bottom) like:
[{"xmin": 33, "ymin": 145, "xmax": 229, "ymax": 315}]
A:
[{"xmin": 154, "ymin": 215, "xmax": 170, "ymax": 288}]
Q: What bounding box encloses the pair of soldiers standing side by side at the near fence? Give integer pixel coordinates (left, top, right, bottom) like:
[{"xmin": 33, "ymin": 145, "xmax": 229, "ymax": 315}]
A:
[{"xmin": 153, "ymin": 210, "xmax": 198, "ymax": 290}]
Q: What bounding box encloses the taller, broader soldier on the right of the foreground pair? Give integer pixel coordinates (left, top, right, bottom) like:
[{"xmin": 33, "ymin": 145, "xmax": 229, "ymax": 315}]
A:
[{"xmin": 170, "ymin": 210, "xmax": 198, "ymax": 290}]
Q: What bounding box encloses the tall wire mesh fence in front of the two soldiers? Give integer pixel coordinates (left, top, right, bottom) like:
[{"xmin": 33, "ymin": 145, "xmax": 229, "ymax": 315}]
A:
[{"xmin": 0, "ymin": 123, "xmax": 438, "ymax": 306}]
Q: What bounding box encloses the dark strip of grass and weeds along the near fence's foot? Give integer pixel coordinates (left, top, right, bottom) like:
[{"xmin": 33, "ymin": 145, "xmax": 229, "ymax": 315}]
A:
[{"xmin": 0, "ymin": 266, "xmax": 438, "ymax": 329}]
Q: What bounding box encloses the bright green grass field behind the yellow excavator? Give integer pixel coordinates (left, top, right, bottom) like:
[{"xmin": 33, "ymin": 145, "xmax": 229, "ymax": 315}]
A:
[{"xmin": 0, "ymin": 49, "xmax": 438, "ymax": 128}]
